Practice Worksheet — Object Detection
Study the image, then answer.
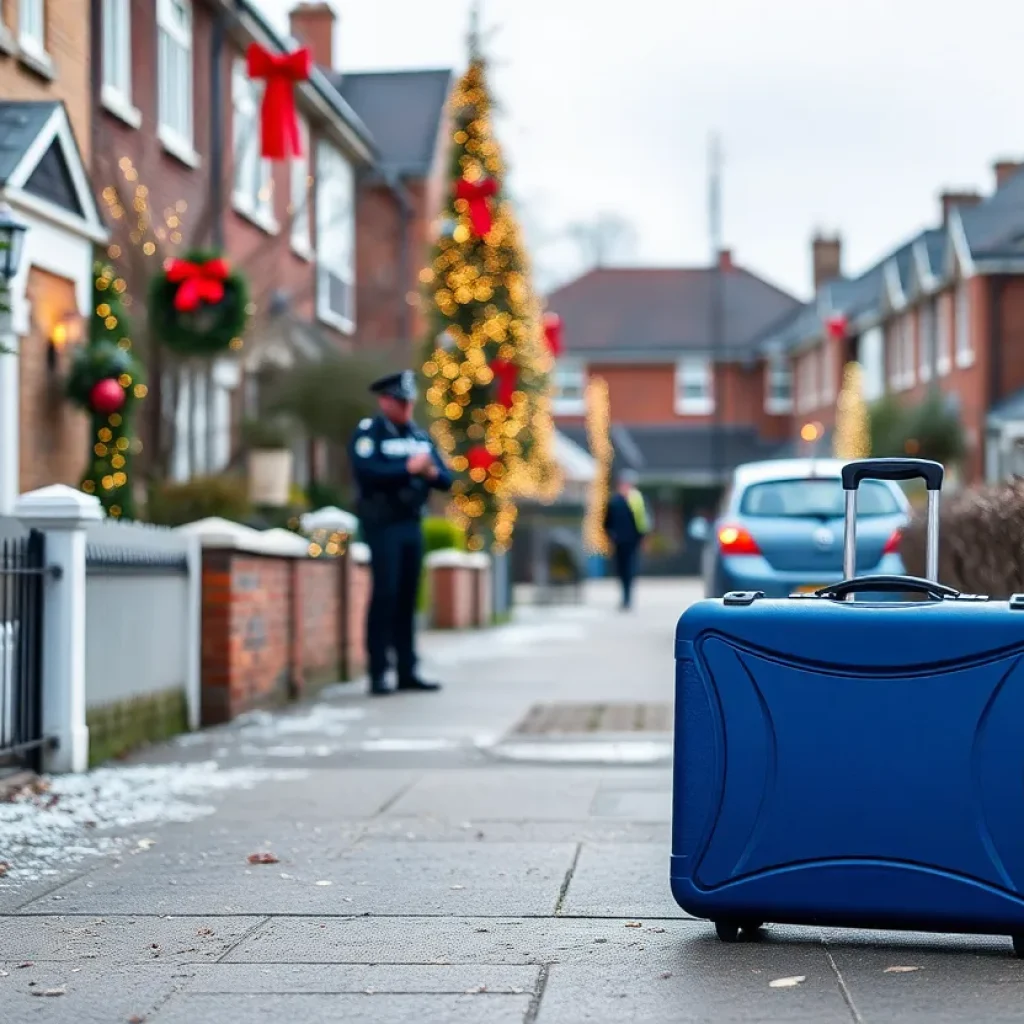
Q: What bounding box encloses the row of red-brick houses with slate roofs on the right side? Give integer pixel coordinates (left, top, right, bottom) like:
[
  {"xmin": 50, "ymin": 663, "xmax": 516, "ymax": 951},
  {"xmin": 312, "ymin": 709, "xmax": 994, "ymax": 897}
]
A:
[{"xmin": 762, "ymin": 161, "xmax": 1024, "ymax": 482}]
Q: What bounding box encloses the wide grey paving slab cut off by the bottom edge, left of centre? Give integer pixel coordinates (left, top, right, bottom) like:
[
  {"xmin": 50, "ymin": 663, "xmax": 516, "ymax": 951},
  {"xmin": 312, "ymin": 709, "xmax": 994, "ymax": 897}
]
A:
[{"xmin": 155, "ymin": 992, "xmax": 530, "ymax": 1024}]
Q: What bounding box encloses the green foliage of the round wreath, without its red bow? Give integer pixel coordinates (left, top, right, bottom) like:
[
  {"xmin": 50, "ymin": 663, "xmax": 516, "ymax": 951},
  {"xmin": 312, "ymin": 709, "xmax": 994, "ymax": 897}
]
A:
[{"xmin": 148, "ymin": 249, "xmax": 249, "ymax": 356}]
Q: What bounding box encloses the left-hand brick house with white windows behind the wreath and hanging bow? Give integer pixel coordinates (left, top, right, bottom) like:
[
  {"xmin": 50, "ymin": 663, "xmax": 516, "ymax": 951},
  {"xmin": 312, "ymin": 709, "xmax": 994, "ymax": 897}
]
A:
[{"xmin": 93, "ymin": 0, "xmax": 375, "ymax": 482}]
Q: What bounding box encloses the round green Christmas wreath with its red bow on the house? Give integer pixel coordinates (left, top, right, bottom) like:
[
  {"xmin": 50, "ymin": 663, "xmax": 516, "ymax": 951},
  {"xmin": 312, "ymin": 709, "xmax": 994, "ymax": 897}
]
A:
[{"xmin": 150, "ymin": 250, "xmax": 249, "ymax": 356}]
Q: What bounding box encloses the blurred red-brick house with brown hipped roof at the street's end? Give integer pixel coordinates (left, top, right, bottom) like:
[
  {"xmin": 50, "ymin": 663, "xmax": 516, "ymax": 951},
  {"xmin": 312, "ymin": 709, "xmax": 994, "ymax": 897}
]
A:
[{"xmin": 548, "ymin": 252, "xmax": 800, "ymax": 570}]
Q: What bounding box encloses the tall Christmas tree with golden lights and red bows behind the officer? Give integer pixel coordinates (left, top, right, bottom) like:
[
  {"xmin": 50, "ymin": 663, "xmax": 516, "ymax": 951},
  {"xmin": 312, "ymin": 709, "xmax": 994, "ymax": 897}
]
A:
[{"xmin": 421, "ymin": 55, "xmax": 561, "ymax": 549}]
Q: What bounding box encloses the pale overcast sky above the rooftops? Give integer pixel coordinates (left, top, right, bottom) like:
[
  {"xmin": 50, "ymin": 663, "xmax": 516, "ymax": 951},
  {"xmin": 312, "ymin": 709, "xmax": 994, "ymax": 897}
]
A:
[{"xmin": 258, "ymin": 0, "xmax": 1024, "ymax": 296}]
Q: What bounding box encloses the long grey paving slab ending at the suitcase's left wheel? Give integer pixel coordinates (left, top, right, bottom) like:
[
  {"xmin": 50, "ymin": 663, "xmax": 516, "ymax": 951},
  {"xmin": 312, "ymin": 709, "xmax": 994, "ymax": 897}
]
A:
[{"xmin": 224, "ymin": 916, "xmax": 714, "ymax": 971}]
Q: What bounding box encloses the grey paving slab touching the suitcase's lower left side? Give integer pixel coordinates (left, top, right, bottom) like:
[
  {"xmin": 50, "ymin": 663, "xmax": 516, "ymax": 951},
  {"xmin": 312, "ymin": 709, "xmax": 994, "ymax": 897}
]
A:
[{"xmin": 559, "ymin": 843, "xmax": 688, "ymax": 918}]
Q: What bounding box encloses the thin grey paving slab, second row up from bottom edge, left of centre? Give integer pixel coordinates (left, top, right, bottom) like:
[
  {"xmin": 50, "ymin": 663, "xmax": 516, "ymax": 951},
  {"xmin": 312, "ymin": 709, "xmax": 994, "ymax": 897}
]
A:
[{"xmin": 182, "ymin": 964, "xmax": 541, "ymax": 995}]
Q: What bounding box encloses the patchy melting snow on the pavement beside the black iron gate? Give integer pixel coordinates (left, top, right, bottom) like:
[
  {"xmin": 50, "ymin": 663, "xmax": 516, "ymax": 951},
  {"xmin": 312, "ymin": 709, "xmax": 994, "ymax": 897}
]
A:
[{"xmin": 0, "ymin": 761, "xmax": 306, "ymax": 888}]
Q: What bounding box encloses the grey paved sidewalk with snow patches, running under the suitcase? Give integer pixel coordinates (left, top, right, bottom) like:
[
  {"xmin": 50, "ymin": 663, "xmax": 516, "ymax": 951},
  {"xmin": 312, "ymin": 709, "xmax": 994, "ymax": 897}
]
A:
[{"xmin": 0, "ymin": 581, "xmax": 1024, "ymax": 1024}]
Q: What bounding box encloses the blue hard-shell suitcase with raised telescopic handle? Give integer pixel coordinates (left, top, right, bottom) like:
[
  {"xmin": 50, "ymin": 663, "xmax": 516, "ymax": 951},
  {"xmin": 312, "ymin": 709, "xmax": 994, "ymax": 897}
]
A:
[{"xmin": 671, "ymin": 459, "xmax": 1024, "ymax": 956}]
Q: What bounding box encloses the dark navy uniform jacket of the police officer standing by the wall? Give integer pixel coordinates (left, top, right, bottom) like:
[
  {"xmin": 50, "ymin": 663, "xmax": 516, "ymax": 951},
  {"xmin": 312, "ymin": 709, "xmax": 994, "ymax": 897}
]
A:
[{"xmin": 349, "ymin": 416, "xmax": 452, "ymax": 527}]
